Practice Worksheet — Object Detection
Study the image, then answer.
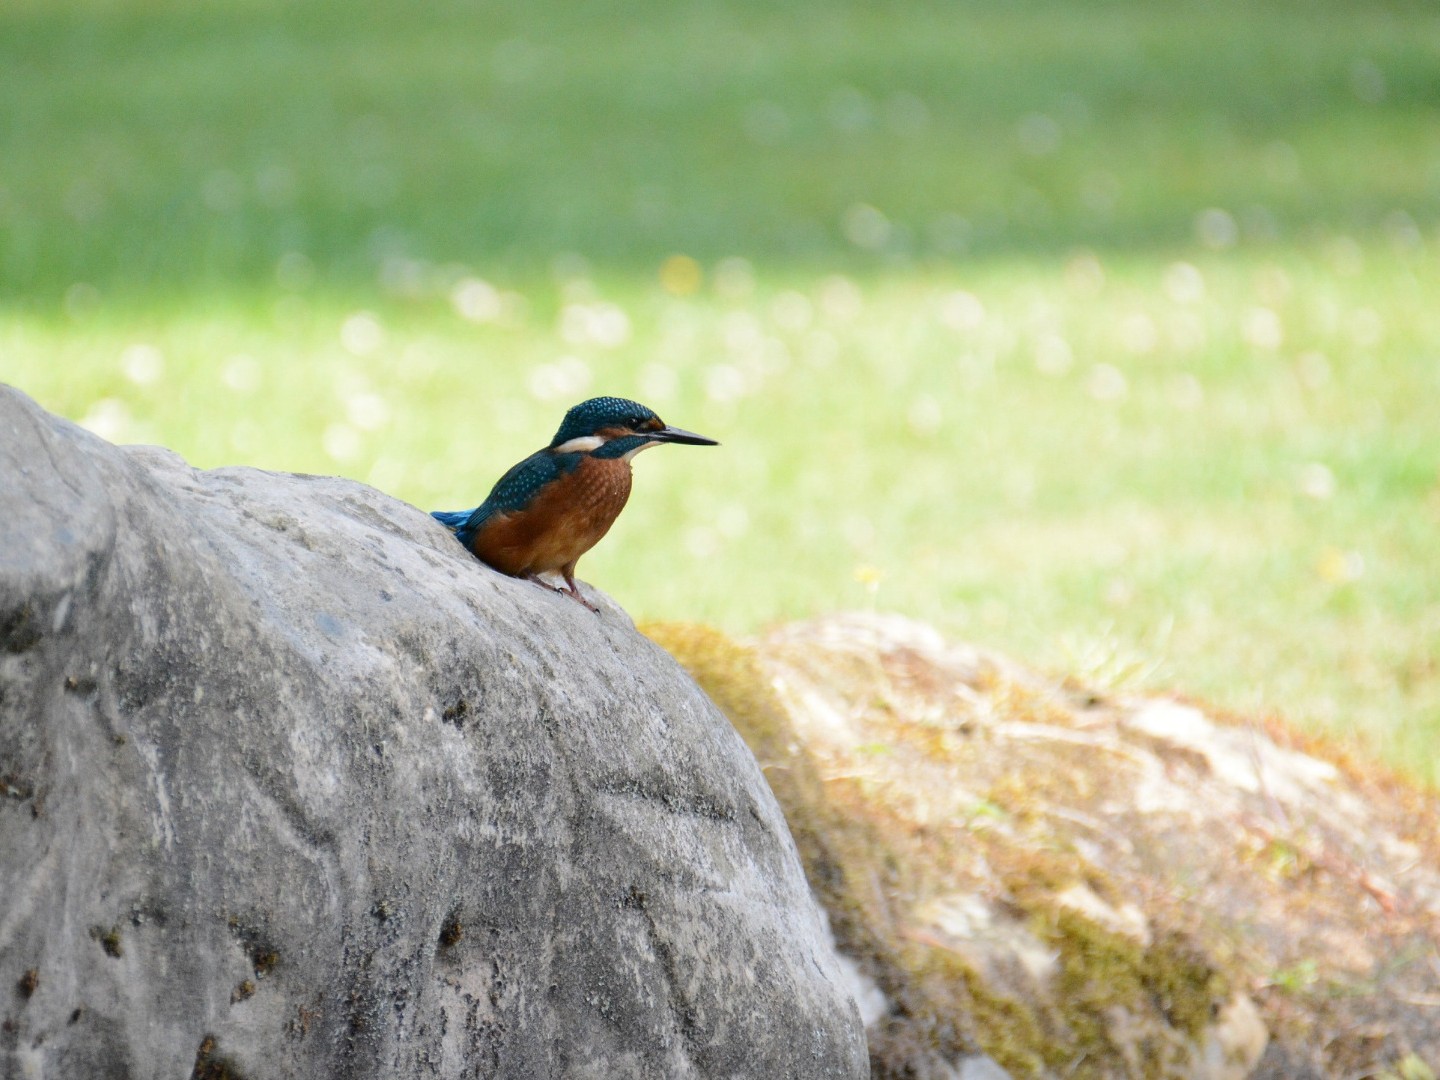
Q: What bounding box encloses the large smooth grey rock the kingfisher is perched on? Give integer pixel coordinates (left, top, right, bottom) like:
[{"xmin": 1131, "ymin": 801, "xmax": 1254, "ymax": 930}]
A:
[{"xmin": 0, "ymin": 390, "xmax": 868, "ymax": 1080}]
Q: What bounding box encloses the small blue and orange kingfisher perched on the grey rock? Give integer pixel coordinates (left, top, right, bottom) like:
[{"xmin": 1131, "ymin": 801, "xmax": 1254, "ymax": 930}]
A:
[{"xmin": 431, "ymin": 397, "xmax": 720, "ymax": 612}]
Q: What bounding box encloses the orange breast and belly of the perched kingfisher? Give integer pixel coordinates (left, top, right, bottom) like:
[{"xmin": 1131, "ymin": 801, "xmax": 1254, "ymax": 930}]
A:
[{"xmin": 475, "ymin": 455, "xmax": 631, "ymax": 577}]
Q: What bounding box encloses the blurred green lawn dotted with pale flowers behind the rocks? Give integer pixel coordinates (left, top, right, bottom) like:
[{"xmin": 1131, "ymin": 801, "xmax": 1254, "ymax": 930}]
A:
[{"xmin": 0, "ymin": 0, "xmax": 1440, "ymax": 780}]
